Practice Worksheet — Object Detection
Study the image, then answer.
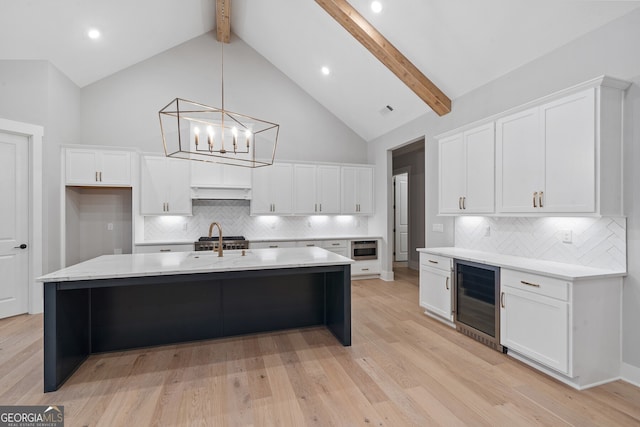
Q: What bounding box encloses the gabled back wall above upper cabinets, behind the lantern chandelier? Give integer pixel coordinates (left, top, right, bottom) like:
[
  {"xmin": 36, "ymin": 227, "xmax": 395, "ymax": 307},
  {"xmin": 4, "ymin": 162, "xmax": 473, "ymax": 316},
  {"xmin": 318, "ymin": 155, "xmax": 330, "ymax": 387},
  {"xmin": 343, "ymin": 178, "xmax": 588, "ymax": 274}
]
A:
[{"xmin": 81, "ymin": 33, "xmax": 367, "ymax": 163}]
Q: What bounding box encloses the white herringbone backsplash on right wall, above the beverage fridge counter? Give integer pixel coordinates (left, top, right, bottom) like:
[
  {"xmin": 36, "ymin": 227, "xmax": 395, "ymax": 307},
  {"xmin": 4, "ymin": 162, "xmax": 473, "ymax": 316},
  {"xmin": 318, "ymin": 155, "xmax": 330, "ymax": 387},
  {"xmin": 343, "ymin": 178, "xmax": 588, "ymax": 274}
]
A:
[{"xmin": 455, "ymin": 217, "xmax": 627, "ymax": 270}]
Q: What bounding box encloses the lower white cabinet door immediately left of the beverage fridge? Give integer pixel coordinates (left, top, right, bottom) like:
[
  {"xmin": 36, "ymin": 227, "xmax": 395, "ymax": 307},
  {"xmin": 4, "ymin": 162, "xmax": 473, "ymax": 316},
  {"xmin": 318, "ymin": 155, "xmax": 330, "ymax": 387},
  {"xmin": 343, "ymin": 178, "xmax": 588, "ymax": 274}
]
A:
[{"xmin": 419, "ymin": 265, "xmax": 453, "ymax": 322}]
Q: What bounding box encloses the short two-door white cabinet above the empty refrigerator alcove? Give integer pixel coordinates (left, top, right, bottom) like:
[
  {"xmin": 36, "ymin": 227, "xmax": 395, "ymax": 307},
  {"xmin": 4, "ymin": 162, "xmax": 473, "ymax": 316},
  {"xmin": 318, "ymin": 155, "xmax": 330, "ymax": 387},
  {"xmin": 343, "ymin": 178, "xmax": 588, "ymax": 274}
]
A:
[{"xmin": 65, "ymin": 148, "xmax": 133, "ymax": 187}]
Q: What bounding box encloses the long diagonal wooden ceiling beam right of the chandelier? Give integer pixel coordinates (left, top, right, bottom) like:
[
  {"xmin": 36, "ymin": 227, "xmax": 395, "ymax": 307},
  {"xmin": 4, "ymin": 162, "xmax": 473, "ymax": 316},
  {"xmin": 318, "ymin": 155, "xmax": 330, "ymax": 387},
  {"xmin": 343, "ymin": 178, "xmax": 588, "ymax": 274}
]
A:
[{"xmin": 316, "ymin": 0, "xmax": 451, "ymax": 116}]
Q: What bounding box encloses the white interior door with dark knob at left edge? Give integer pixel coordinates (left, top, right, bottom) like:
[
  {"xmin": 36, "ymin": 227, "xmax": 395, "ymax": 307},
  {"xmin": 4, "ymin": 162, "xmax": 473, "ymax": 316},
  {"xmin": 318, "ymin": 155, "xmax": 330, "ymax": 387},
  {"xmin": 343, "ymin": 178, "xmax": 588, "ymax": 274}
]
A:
[{"xmin": 0, "ymin": 132, "xmax": 29, "ymax": 318}]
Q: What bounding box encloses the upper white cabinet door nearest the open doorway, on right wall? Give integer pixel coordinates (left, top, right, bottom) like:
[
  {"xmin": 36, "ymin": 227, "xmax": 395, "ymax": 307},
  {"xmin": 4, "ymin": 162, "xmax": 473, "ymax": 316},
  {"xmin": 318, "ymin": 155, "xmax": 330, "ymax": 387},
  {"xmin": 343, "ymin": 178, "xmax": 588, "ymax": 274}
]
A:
[{"xmin": 439, "ymin": 133, "xmax": 466, "ymax": 213}]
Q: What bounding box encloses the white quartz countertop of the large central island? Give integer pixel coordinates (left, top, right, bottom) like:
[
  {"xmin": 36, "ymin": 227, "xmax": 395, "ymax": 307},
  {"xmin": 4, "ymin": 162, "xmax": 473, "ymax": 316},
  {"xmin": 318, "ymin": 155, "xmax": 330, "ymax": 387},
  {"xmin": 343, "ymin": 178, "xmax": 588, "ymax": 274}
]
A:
[{"xmin": 37, "ymin": 247, "xmax": 354, "ymax": 282}]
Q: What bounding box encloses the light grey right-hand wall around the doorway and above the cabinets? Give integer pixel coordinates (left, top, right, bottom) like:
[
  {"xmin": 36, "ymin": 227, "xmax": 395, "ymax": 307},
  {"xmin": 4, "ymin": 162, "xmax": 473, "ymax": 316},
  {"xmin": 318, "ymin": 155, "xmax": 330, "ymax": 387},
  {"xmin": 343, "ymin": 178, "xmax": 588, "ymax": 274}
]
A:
[{"xmin": 369, "ymin": 10, "xmax": 640, "ymax": 372}]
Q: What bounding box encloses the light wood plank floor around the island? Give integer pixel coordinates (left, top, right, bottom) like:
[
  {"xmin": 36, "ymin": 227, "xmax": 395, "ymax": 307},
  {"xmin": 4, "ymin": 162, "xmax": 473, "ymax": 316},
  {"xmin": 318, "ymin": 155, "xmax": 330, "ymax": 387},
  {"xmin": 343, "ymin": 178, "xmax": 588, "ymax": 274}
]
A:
[{"xmin": 0, "ymin": 269, "xmax": 640, "ymax": 426}]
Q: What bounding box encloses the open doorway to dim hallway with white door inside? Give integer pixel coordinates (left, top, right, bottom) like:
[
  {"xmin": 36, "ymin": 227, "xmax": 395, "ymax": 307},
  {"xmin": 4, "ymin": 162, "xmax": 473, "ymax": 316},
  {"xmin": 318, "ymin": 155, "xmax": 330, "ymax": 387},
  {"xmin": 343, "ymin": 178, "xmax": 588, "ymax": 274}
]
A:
[{"xmin": 390, "ymin": 139, "xmax": 425, "ymax": 275}]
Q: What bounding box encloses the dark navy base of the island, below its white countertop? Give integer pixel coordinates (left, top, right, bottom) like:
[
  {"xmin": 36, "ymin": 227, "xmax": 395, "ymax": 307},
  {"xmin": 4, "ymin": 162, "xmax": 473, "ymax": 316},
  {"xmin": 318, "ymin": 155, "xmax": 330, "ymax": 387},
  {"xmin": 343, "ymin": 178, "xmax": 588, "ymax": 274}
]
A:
[{"xmin": 44, "ymin": 264, "xmax": 351, "ymax": 392}]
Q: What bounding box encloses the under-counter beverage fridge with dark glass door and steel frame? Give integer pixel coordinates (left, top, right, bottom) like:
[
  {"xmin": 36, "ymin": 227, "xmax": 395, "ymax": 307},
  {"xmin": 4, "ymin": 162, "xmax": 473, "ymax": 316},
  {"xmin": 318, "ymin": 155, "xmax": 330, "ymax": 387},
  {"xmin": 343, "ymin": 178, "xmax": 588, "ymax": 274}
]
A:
[{"xmin": 454, "ymin": 260, "xmax": 505, "ymax": 352}]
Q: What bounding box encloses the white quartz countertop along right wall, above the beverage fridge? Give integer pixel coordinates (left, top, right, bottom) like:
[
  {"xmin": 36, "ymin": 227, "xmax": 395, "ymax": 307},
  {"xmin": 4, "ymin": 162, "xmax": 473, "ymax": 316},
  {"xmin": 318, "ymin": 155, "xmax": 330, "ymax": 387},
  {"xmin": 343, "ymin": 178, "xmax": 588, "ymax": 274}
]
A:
[{"xmin": 417, "ymin": 247, "xmax": 627, "ymax": 281}]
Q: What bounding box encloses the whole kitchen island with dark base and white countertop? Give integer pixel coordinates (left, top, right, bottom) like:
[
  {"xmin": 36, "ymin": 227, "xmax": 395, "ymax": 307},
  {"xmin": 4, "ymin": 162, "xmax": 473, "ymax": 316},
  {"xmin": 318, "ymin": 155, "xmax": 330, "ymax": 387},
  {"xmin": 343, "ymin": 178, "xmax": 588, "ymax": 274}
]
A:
[{"xmin": 38, "ymin": 247, "xmax": 353, "ymax": 392}]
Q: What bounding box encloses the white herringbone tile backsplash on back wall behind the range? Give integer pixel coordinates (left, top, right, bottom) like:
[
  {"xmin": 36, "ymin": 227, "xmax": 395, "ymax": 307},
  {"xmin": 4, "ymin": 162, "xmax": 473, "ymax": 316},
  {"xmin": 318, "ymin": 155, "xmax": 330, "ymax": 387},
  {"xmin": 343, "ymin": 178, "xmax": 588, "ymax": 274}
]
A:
[{"xmin": 144, "ymin": 200, "xmax": 368, "ymax": 241}]
